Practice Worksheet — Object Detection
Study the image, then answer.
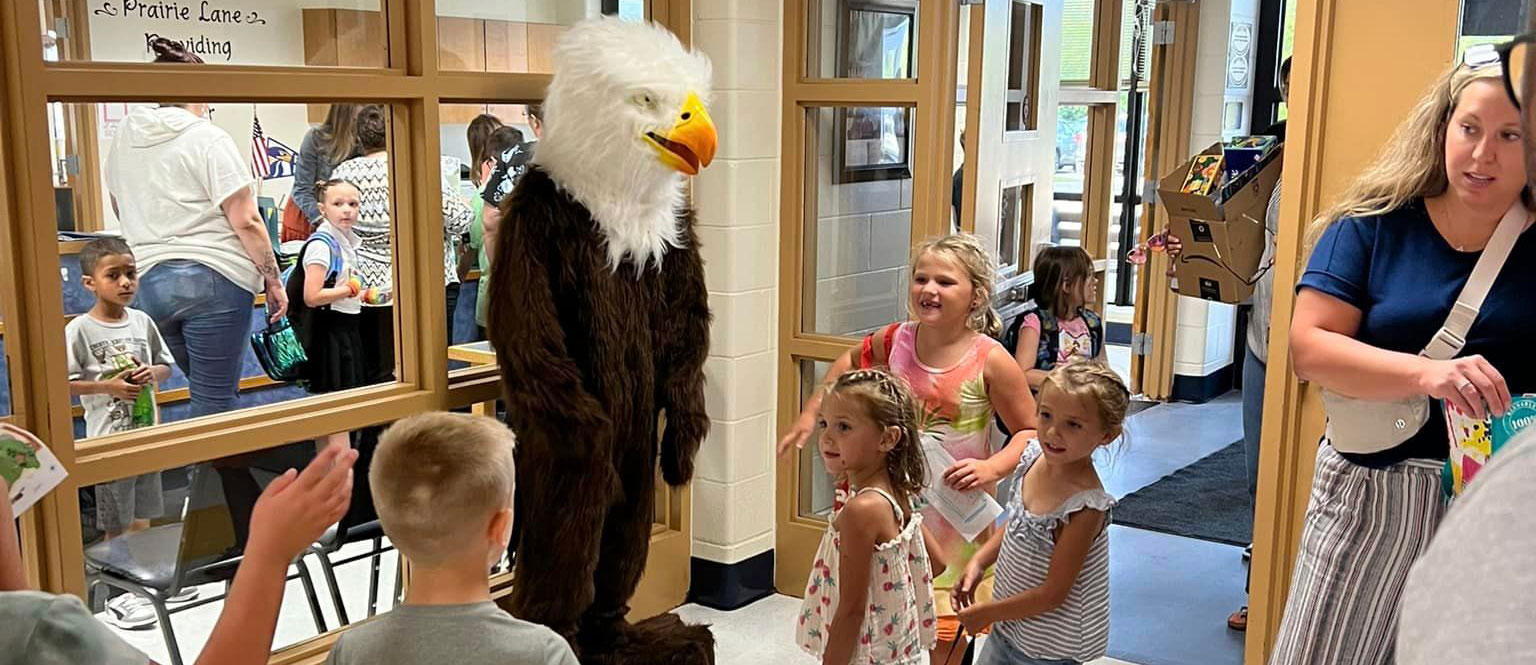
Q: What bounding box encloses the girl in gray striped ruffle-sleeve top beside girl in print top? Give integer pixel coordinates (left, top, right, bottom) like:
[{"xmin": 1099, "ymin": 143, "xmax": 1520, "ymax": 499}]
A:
[{"xmin": 954, "ymin": 361, "xmax": 1130, "ymax": 665}]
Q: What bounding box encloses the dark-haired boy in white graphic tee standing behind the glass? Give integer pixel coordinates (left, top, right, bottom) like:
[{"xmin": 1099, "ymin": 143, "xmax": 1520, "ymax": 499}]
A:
[{"xmin": 65, "ymin": 238, "xmax": 184, "ymax": 628}]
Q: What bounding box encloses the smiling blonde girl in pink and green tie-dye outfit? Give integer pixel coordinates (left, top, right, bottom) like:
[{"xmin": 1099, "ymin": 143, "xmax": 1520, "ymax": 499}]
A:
[{"xmin": 779, "ymin": 233, "xmax": 1035, "ymax": 665}]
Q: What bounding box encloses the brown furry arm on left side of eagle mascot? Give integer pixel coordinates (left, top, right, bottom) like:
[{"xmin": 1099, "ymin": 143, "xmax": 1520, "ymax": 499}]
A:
[{"xmin": 487, "ymin": 207, "xmax": 611, "ymax": 458}]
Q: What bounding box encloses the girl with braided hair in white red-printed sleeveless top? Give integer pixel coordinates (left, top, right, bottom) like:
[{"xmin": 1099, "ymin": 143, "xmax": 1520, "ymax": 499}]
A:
[{"xmin": 796, "ymin": 370, "xmax": 942, "ymax": 665}]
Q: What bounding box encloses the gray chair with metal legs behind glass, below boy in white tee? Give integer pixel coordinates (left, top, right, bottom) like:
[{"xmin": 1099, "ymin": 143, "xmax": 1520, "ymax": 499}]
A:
[{"xmin": 84, "ymin": 464, "xmax": 327, "ymax": 665}]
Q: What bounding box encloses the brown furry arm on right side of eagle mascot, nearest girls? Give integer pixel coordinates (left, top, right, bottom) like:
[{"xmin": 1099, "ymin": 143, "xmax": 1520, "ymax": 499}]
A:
[{"xmin": 657, "ymin": 215, "xmax": 710, "ymax": 485}]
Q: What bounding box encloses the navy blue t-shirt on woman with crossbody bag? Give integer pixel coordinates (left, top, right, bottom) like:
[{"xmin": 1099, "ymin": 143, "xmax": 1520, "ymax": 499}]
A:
[{"xmin": 1296, "ymin": 200, "xmax": 1536, "ymax": 467}]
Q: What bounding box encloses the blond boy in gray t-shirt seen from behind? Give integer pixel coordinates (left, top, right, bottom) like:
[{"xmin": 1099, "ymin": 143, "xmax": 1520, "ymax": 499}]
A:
[{"xmin": 326, "ymin": 413, "xmax": 578, "ymax": 665}]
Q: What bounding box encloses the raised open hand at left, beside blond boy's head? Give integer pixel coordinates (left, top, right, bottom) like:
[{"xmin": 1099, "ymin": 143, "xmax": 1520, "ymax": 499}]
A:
[{"xmin": 246, "ymin": 445, "xmax": 358, "ymax": 564}]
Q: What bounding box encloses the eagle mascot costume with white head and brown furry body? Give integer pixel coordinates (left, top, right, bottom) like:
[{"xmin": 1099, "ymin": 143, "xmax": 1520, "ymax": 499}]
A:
[{"xmin": 488, "ymin": 18, "xmax": 716, "ymax": 665}]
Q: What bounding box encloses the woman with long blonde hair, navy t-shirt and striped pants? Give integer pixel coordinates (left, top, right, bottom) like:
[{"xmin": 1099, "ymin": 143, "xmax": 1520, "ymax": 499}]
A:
[{"xmin": 1270, "ymin": 49, "xmax": 1536, "ymax": 665}]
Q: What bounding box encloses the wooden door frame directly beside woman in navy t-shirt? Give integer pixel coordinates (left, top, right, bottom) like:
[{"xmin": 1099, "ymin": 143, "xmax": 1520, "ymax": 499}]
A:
[{"xmin": 1244, "ymin": 0, "xmax": 1459, "ymax": 654}]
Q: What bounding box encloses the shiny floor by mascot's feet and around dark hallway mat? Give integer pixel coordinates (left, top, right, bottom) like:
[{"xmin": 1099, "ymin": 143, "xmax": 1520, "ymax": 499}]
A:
[{"xmin": 677, "ymin": 392, "xmax": 1247, "ymax": 665}]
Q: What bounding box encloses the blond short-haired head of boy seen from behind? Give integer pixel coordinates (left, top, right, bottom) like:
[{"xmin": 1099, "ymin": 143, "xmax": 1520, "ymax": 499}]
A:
[{"xmin": 369, "ymin": 413, "xmax": 516, "ymax": 567}]
